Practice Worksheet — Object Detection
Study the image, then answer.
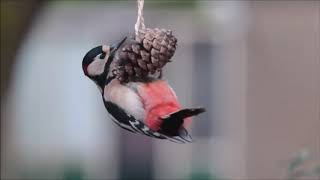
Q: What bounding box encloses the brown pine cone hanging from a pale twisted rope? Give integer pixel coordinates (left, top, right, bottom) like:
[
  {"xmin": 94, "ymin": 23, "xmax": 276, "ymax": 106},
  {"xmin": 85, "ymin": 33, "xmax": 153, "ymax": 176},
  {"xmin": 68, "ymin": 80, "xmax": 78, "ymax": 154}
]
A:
[{"xmin": 112, "ymin": 28, "xmax": 177, "ymax": 82}]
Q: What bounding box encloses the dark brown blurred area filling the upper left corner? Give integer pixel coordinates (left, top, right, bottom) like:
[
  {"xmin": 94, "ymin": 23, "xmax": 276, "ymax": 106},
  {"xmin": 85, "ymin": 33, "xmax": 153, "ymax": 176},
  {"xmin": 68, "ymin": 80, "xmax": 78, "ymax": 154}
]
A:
[{"xmin": 0, "ymin": 0, "xmax": 39, "ymax": 96}]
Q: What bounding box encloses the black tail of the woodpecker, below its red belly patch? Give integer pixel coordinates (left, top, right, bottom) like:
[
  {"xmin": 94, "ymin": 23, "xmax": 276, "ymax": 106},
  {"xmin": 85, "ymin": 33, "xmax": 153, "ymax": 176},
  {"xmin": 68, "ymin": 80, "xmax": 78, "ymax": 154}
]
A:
[{"xmin": 160, "ymin": 108, "xmax": 205, "ymax": 136}]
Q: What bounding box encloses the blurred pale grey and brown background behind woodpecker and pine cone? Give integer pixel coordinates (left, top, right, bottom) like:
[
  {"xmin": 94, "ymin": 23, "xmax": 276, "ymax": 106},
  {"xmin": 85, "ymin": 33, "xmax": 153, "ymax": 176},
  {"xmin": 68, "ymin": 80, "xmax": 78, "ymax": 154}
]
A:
[{"xmin": 1, "ymin": 0, "xmax": 320, "ymax": 180}]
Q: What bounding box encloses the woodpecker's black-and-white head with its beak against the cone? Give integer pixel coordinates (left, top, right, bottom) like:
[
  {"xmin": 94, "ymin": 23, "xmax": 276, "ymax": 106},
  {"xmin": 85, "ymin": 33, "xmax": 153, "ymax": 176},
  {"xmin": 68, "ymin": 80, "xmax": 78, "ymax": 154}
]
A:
[{"xmin": 82, "ymin": 37, "xmax": 126, "ymax": 86}]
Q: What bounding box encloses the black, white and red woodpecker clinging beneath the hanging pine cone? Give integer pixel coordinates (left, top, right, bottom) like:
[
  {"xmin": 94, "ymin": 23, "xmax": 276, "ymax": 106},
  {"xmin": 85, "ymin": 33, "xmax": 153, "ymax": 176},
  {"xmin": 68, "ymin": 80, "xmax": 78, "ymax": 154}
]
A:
[{"xmin": 82, "ymin": 38, "xmax": 205, "ymax": 143}]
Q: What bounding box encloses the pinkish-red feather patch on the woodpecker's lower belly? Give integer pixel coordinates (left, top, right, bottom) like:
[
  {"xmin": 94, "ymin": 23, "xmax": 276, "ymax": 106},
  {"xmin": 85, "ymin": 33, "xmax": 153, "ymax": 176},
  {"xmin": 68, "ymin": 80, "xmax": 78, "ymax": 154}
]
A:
[{"xmin": 138, "ymin": 80, "xmax": 188, "ymax": 131}]
